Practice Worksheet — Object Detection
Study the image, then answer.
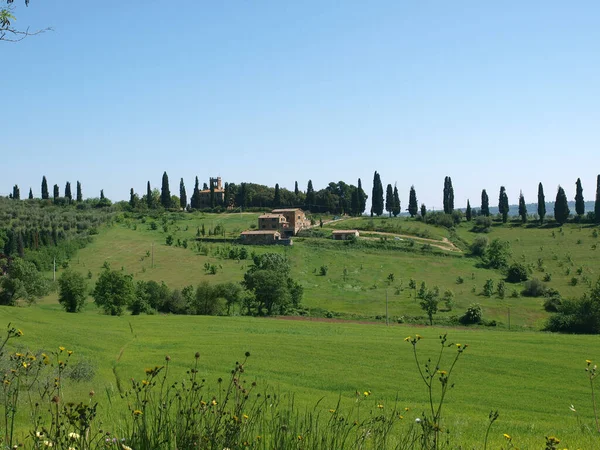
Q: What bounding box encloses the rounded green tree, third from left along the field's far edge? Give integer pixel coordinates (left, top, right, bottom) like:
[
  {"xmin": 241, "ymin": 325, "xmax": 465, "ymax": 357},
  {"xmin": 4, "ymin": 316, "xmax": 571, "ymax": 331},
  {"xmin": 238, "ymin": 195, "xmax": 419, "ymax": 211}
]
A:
[{"xmin": 92, "ymin": 269, "xmax": 135, "ymax": 316}]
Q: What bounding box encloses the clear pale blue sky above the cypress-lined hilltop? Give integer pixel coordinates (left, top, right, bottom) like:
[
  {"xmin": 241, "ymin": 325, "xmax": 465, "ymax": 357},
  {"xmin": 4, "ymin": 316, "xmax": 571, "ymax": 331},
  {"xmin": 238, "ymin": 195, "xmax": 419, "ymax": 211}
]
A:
[{"xmin": 0, "ymin": 0, "xmax": 600, "ymax": 209}]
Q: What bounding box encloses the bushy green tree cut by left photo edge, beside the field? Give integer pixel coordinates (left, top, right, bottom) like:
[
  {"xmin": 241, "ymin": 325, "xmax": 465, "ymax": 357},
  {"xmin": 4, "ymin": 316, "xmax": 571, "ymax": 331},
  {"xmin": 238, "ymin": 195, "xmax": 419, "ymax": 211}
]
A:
[{"xmin": 0, "ymin": 258, "xmax": 50, "ymax": 306}]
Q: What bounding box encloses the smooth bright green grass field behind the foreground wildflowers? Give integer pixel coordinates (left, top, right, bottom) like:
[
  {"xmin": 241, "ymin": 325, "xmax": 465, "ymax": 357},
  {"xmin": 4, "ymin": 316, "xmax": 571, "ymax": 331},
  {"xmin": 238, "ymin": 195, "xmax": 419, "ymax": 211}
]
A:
[{"xmin": 0, "ymin": 305, "xmax": 600, "ymax": 448}]
